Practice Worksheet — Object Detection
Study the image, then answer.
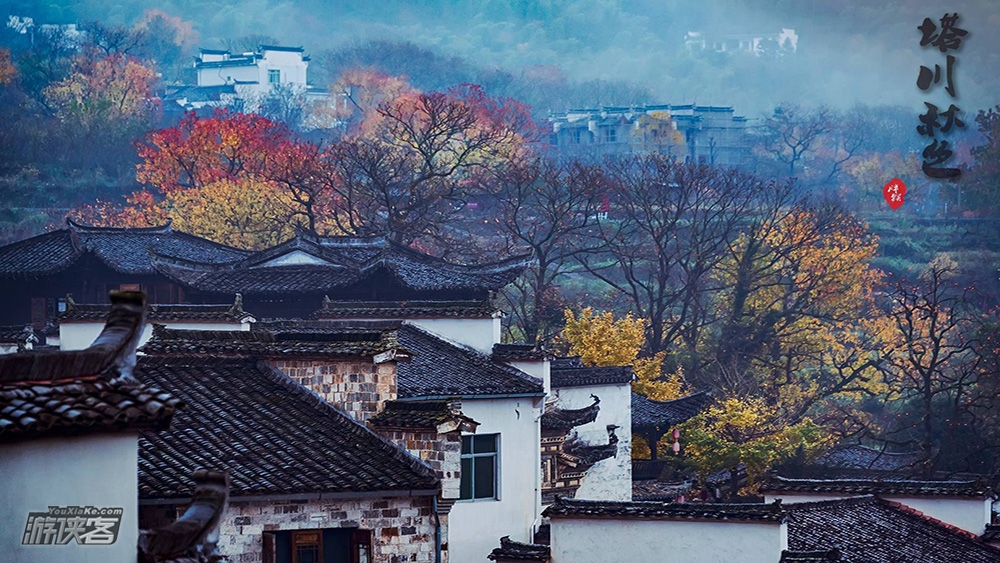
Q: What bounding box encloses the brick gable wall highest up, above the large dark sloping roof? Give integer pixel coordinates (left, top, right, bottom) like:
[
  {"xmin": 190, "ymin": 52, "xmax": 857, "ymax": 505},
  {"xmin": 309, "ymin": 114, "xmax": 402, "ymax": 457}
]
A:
[{"xmin": 270, "ymin": 359, "xmax": 396, "ymax": 423}]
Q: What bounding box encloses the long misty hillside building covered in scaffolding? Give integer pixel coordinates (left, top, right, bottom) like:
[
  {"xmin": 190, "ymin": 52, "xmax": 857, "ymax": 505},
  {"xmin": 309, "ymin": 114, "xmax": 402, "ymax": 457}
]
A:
[{"xmin": 549, "ymin": 104, "xmax": 752, "ymax": 166}]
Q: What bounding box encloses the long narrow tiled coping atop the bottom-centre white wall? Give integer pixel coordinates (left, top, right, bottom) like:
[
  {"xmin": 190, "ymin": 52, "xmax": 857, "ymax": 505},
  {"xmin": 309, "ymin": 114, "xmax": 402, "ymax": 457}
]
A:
[{"xmin": 542, "ymin": 497, "xmax": 785, "ymax": 523}]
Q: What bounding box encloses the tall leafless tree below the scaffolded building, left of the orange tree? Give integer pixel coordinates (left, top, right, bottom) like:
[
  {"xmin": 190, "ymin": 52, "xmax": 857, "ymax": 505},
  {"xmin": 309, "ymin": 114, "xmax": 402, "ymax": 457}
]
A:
[{"xmin": 578, "ymin": 155, "xmax": 774, "ymax": 368}]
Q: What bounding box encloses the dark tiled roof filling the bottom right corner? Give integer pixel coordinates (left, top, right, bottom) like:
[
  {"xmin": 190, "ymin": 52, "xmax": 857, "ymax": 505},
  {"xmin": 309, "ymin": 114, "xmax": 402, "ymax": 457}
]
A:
[{"xmin": 784, "ymin": 497, "xmax": 1000, "ymax": 563}]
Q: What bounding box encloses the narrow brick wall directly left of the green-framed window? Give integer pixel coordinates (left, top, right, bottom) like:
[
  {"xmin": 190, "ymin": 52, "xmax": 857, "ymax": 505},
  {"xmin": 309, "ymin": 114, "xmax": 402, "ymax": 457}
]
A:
[{"xmin": 375, "ymin": 428, "xmax": 462, "ymax": 499}]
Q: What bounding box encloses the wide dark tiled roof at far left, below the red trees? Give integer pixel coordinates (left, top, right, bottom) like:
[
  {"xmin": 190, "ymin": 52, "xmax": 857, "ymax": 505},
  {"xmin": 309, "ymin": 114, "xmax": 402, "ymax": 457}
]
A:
[{"xmin": 0, "ymin": 222, "xmax": 247, "ymax": 278}]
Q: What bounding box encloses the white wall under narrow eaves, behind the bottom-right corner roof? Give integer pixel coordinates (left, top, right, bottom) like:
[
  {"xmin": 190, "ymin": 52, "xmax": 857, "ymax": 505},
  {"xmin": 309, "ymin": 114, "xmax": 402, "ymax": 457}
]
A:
[{"xmin": 764, "ymin": 493, "xmax": 993, "ymax": 536}]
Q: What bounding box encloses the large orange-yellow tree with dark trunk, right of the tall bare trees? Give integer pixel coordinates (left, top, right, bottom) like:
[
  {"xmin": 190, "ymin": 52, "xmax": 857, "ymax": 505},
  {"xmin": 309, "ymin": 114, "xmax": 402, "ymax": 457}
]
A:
[{"xmin": 712, "ymin": 207, "xmax": 884, "ymax": 419}]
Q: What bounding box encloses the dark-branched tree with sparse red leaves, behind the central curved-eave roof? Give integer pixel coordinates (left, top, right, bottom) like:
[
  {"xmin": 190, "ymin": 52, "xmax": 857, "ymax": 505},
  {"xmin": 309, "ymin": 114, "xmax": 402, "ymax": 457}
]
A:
[{"xmin": 331, "ymin": 86, "xmax": 534, "ymax": 244}]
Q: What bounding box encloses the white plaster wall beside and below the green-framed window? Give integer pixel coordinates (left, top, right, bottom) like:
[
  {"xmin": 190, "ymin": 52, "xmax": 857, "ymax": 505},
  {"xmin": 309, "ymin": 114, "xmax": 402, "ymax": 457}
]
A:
[{"xmin": 448, "ymin": 397, "xmax": 542, "ymax": 563}]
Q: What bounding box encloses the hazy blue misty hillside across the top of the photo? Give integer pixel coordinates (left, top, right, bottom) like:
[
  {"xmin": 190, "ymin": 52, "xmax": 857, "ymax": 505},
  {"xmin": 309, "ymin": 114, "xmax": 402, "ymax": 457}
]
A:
[{"xmin": 0, "ymin": 0, "xmax": 1000, "ymax": 115}]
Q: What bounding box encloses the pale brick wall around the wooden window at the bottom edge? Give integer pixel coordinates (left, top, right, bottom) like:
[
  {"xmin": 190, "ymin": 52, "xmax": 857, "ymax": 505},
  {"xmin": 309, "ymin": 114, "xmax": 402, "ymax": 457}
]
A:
[{"xmin": 149, "ymin": 497, "xmax": 448, "ymax": 563}]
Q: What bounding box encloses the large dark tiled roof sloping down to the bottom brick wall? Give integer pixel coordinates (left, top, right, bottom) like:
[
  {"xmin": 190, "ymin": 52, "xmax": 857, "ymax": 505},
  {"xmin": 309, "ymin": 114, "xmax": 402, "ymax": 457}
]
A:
[{"xmin": 136, "ymin": 356, "xmax": 438, "ymax": 499}]
